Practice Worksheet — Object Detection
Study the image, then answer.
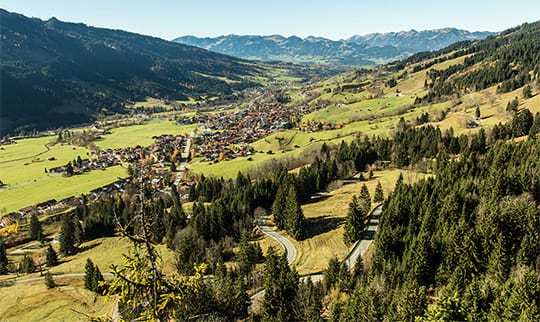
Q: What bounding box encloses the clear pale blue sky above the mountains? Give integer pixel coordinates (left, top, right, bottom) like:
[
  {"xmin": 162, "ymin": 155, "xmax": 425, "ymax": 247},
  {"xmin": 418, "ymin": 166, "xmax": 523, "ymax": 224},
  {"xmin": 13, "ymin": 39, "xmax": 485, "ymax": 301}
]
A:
[{"xmin": 0, "ymin": 0, "xmax": 540, "ymax": 40}]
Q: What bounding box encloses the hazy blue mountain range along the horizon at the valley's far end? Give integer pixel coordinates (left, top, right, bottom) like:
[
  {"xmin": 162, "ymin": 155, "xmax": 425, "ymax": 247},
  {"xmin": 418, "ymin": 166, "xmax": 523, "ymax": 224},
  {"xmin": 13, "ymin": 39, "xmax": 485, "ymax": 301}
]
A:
[{"xmin": 173, "ymin": 28, "xmax": 497, "ymax": 66}]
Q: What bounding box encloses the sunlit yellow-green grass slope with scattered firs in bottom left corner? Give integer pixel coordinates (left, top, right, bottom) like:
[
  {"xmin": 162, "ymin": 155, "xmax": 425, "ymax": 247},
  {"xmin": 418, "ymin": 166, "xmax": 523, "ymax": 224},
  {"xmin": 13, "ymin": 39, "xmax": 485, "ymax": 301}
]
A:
[{"xmin": 0, "ymin": 237, "xmax": 174, "ymax": 321}]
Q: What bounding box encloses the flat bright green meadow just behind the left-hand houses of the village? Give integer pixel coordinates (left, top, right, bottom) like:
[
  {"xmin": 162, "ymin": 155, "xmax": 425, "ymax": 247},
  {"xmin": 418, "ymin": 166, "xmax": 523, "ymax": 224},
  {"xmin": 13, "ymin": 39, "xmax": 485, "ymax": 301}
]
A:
[{"xmin": 95, "ymin": 120, "xmax": 198, "ymax": 149}]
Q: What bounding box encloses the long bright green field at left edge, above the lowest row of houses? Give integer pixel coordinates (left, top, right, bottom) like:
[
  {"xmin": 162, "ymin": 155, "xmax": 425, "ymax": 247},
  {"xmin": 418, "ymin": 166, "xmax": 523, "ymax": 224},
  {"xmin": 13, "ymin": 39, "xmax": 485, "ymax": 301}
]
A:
[{"xmin": 0, "ymin": 166, "xmax": 127, "ymax": 212}]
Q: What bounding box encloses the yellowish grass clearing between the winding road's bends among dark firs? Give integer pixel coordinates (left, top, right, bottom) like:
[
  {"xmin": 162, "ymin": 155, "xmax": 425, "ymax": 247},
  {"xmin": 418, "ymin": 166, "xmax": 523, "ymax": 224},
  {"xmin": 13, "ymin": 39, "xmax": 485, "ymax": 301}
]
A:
[{"xmin": 293, "ymin": 170, "xmax": 426, "ymax": 274}]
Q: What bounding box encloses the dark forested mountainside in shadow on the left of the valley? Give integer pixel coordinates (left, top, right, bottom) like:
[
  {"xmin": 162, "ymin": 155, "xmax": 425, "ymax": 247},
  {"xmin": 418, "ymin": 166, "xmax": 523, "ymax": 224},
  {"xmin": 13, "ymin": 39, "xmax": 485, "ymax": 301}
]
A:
[{"xmin": 0, "ymin": 10, "xmax": 258, "ymax": 133}]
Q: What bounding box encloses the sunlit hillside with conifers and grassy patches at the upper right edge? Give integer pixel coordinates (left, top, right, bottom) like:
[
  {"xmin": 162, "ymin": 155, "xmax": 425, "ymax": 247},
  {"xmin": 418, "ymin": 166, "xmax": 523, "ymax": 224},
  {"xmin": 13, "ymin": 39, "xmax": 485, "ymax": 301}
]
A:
[{"xmin": 397, "ymin": 22, "xmax": 540, "ymax": 102}]
